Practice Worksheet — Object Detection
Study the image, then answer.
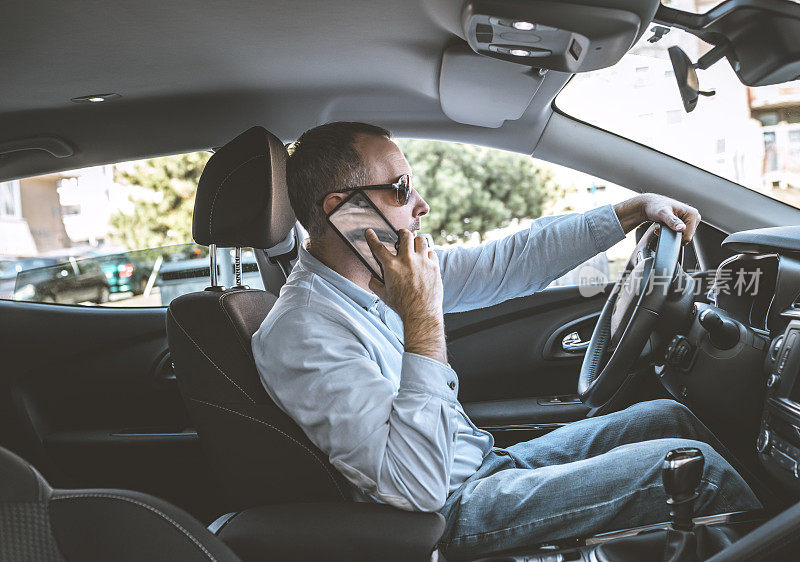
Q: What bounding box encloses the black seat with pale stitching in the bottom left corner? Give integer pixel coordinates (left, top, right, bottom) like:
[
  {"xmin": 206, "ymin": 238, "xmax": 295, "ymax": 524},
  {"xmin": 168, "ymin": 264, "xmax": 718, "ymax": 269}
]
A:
[{"xmin": 0, "ymin": 447, "xmax": 239, "ymax": 562}]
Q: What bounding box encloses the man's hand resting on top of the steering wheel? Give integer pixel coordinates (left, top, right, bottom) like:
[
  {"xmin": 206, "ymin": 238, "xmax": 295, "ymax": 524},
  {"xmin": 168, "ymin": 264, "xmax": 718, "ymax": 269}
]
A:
[{"xmin": 614, "ymin": 193, "xmax": 700, "ymax": 245}]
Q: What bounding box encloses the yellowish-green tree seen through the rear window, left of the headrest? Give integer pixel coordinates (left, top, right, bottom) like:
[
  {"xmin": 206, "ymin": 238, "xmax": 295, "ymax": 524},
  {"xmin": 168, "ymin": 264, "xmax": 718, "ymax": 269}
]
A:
[{"xmin": 111, "ymin": 152, "xmax": 210, "ymax": 250}]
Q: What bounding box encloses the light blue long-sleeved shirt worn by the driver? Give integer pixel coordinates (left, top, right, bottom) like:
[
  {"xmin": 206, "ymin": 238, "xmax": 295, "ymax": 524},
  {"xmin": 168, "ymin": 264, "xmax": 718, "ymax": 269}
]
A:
[{"xmin": 252, "ymin": 205, "xmax": 625, "ymax": 511}]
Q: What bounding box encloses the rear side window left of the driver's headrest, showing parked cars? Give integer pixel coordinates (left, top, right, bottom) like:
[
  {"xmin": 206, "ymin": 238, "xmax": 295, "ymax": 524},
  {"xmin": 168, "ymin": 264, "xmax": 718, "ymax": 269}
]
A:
[{"xmin": 0, "ymin": 152, "xmax": 264, "ymax": 307}]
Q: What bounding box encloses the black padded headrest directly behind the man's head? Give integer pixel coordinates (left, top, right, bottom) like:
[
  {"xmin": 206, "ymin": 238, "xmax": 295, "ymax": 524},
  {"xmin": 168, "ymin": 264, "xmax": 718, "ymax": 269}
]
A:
[{"xmin": 192, "ymin": 127, "xmax": 295, "ymax": 249}]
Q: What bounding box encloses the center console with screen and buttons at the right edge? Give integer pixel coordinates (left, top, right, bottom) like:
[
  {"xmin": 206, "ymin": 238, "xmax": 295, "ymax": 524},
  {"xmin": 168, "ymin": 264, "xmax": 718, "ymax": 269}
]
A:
[{"xmin": 756, "ymin": 320, "xmax": 800, "ymax": 492}]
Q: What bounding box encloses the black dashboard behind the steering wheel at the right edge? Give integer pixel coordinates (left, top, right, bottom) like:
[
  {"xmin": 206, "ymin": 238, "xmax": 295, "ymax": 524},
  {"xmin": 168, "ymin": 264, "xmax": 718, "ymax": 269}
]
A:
[{"xmin": 656, "ymin": 223, "xmax": 800, "ymax": 496}]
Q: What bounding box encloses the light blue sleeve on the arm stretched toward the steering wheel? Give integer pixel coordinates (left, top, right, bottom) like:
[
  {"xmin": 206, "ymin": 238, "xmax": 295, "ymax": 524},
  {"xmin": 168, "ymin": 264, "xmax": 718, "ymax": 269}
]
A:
[{"xmin": 436, "ymin": 205, "xmax": 625, "ymax": 313}]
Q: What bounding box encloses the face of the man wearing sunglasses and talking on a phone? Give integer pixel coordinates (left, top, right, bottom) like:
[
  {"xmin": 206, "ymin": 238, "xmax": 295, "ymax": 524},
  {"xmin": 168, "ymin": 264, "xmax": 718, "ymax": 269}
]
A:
[{"xmin": 356, "ymin": 135, "xmax": 430, "ymax": 232}]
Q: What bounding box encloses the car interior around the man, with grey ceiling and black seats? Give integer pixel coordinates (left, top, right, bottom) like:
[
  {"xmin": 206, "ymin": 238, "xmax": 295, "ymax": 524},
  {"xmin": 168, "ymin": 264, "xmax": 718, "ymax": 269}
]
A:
[{"xmin": 0, "ymin": 0, "xmax": 800, "ymax": 562}]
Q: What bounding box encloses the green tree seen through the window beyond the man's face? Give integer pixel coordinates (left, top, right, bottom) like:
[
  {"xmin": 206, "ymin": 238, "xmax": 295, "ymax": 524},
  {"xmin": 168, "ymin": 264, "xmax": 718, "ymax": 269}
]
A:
[{"xmin": 398, "ymin": 140, "xmax": 561, "ymax": 244}]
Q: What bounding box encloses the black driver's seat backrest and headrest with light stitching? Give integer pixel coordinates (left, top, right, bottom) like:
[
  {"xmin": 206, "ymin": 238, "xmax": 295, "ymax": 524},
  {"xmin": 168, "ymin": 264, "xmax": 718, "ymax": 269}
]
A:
[{"xmin": 167, "ymin": 127, "xmax": 350, "ymax": 509}]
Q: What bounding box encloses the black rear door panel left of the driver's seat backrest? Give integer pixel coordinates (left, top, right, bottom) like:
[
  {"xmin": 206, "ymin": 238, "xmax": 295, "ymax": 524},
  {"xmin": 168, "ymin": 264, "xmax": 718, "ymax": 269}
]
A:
[{"xmin": 0, "ymin": 301, "xmax": 223, "ymax": 520}]
